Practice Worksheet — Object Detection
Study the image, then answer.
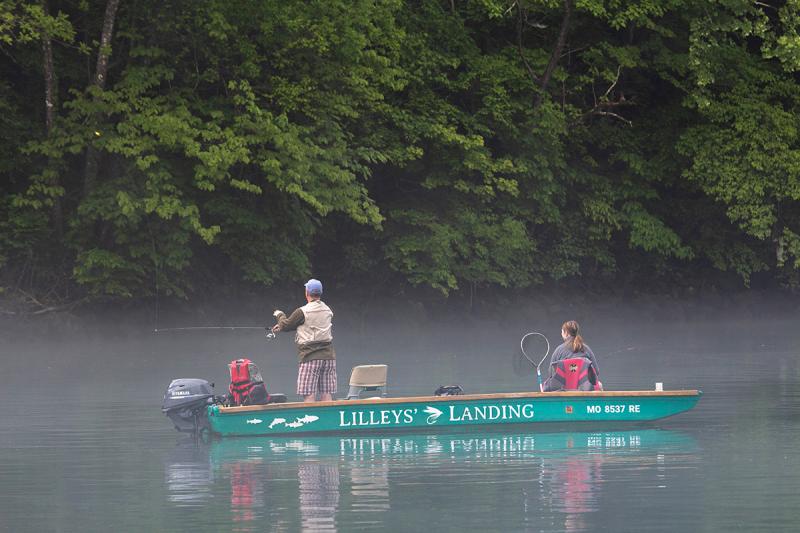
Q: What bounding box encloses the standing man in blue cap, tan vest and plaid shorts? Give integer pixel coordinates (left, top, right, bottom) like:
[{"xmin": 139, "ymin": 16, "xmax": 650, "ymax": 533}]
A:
[{"xmin": 272, "ymin": 279, "xmax": 336, "ymax": 402}]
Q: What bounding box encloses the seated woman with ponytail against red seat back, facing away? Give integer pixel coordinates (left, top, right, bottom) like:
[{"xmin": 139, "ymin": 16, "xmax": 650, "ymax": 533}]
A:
[{"xmin": 544, "ymin": 320, "xmax": 603, "ymax": 392}]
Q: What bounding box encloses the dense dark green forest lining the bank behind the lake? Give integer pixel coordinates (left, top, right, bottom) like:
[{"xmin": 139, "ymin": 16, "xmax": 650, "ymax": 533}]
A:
[{"xmin": 0, "ymin": 0, "xmax": 800, "ymax": 314}]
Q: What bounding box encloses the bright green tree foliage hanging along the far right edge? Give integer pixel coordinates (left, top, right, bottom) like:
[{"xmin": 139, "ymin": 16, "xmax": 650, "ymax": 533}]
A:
[{"xmin": 677, "ymin": 2, "xmax": 800, "ymax": 278}]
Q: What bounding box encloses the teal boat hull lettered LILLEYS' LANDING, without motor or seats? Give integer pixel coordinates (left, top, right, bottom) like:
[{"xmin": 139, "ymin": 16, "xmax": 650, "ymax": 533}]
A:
[{"xmin": 208, "ymin": 390, "xmax": 702, "ymax": 436}]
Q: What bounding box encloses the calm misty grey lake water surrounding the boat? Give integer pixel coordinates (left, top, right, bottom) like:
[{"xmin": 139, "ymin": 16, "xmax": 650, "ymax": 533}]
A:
[{"xmin": 0, "ymin": 302, "xmax": 800, "ymax": 532}]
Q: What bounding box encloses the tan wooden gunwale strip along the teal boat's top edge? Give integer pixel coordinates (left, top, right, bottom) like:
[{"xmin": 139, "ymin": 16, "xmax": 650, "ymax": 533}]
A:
[{"xmin": 214, "ymin": 389, "xmax": 703, "ymax": 415}]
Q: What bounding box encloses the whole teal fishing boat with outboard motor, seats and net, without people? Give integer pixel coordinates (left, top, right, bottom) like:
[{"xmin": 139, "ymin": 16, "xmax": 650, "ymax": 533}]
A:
[{"xmin": 162, "ymin": 340, "xmax": 702, "ymax": 437}]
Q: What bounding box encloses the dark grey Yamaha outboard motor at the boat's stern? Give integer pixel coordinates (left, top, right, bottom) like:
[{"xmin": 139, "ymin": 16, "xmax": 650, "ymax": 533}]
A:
[{"xmin": 161, "ymin": 378, "xmax": 223, "ymax": 434}]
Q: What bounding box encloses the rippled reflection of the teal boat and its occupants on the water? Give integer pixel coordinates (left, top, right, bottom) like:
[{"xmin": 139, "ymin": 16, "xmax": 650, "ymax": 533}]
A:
[{"xmin": 170, "ymin": 429, "xmax": 696, "ymax": 531}]
